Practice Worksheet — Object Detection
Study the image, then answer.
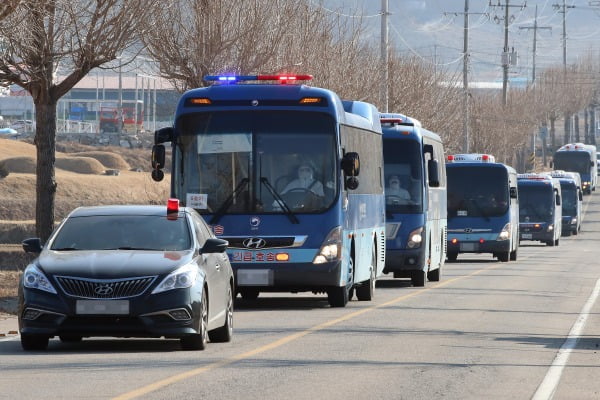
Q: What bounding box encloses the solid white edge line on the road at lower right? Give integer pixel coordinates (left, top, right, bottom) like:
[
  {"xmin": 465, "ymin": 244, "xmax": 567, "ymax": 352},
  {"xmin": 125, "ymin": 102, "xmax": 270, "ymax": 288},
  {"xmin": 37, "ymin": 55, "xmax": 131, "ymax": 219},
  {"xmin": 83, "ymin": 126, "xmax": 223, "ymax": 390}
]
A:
[{"xmin": 532, "ymin": 279, "xmax": 600, "ymax": 400}]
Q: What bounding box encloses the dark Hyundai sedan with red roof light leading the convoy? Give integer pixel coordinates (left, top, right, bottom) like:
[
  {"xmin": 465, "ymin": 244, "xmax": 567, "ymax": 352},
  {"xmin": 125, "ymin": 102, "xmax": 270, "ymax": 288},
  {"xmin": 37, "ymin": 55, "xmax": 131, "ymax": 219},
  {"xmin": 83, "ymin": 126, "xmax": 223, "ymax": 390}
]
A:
[{"xmin": 19, "ymin": 200, "xmax": 233, "ymax": 350}]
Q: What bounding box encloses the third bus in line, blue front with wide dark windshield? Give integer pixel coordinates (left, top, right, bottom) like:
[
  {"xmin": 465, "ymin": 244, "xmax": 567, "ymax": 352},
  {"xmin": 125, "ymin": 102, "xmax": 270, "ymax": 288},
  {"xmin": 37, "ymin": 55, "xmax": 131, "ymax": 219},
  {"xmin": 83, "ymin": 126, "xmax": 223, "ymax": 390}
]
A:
[{"xmin": 446, "ymin": 154, "xmax": 519, "ymax": 262}]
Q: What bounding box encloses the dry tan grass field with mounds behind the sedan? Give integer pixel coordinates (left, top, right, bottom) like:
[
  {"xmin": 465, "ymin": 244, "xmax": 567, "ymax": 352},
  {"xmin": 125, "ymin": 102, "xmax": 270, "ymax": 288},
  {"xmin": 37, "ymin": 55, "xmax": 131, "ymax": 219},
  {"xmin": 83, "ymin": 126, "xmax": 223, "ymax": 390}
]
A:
[{"xmin": 0, "ymin": 139, "xmax": 170, "ymax": 313}]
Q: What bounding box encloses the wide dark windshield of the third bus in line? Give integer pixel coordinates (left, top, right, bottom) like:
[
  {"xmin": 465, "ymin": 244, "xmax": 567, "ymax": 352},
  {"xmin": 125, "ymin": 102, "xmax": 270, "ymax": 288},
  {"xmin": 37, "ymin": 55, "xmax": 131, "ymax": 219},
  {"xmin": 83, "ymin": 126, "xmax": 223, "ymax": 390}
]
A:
[{"xmin": 446, "ymin": 166, "xmax": 509, "ymax": 218}]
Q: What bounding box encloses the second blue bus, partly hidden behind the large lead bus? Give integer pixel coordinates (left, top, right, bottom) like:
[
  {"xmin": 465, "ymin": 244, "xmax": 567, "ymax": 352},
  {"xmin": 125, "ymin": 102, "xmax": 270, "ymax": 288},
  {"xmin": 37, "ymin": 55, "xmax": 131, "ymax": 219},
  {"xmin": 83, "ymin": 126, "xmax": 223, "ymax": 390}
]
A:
[{"xmin": 381, "ymin": 114, "xmax": 447, "ymax": 286}]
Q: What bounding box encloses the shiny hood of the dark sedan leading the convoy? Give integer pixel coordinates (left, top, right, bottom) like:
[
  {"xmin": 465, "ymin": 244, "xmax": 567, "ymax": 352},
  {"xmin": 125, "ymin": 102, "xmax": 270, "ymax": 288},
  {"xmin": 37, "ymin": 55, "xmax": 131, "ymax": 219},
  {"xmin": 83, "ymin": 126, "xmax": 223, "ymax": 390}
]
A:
[{"xmin": 37, "ymin": 250, "xmax": 194, "ymax": 279}]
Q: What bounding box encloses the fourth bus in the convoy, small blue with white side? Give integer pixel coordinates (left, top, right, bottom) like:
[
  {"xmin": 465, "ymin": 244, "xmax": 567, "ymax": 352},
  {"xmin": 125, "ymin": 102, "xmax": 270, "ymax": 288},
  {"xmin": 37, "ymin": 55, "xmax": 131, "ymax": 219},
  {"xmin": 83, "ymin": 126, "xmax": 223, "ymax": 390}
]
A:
[{"xmin": 517, "ymin": 173, "xmax": 562, "ymax": 246}]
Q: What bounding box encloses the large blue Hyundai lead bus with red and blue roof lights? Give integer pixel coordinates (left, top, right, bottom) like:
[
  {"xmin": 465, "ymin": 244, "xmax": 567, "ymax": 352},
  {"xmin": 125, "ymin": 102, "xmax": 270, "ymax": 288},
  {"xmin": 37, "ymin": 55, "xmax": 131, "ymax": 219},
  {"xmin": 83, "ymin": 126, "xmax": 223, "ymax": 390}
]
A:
[{"xmin": 152, "ymin": 75, "xmax": 385, "ymax": 307}]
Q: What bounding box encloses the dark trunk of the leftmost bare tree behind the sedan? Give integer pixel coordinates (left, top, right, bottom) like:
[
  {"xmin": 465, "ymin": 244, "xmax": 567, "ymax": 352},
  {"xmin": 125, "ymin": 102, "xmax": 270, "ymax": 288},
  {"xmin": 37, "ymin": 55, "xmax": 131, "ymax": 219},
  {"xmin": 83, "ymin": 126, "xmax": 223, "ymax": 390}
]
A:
[{"xmin": 35, "ymin": 100, "xmax": 56, "ymax": 243}]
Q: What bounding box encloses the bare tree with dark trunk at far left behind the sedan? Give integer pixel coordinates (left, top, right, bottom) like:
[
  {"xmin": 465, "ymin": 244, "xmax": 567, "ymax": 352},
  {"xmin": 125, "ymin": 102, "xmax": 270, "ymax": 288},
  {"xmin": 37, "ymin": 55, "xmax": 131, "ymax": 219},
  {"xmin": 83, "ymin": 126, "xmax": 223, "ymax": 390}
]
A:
[{"xmin": 0, "ymin": 0, "xmax": 166, "ymax": 240}]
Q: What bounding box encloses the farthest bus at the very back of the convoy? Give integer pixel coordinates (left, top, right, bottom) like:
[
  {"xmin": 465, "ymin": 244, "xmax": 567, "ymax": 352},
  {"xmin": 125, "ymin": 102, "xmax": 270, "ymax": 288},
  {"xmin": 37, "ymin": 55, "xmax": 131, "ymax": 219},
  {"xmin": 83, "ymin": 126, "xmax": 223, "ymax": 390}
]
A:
[{"xmin": 553, "ymin": 143, "xmax": 598, "ymax": 194}]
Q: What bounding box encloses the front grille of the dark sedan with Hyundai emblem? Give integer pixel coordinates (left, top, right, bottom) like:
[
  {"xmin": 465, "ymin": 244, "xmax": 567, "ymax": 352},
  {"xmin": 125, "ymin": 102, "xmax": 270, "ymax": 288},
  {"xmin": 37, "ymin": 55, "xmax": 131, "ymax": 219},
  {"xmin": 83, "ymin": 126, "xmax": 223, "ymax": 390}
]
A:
[{"xmin": 56, "ymin": 276, "xmax": 156, "ymax": 299}]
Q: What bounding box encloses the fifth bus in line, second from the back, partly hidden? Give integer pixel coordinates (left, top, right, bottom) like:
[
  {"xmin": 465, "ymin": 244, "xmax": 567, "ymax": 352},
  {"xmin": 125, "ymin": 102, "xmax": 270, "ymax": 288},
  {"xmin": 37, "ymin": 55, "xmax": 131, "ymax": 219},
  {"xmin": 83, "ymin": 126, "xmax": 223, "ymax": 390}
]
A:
[{"xmin": 550, "ymin": 171, "xmax": 583, "ymax": 236}]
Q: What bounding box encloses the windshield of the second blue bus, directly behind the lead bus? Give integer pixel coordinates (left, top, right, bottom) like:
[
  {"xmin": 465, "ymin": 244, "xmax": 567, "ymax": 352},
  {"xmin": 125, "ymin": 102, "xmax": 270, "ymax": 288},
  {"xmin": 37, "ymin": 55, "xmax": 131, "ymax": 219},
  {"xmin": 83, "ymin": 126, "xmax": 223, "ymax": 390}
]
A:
[{"xmin": 383, "ymin": 140, "xmax": 423, "ymax": 214}]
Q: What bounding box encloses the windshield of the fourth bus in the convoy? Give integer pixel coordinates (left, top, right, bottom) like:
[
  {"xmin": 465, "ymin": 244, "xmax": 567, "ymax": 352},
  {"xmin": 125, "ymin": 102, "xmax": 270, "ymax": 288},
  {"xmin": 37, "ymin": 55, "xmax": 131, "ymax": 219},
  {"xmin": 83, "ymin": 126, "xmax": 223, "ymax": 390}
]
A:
[{"xmin": 519, "ymin": 185, "xmax": 554, "ymax": 222}]
